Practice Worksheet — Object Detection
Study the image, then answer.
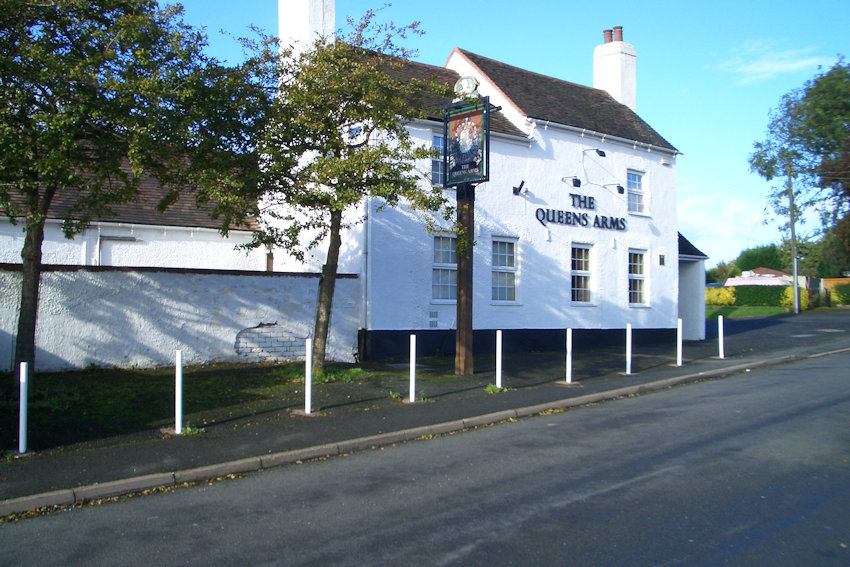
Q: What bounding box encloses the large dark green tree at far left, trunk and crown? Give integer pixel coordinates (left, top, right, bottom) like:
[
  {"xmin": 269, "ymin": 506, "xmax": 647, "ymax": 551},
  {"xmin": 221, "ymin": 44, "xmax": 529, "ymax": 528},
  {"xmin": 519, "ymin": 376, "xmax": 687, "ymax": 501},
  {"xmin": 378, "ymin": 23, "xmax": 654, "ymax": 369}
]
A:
[{"xmin": 0, "ymin": 0, "xmax": 277, "ymax": 394}]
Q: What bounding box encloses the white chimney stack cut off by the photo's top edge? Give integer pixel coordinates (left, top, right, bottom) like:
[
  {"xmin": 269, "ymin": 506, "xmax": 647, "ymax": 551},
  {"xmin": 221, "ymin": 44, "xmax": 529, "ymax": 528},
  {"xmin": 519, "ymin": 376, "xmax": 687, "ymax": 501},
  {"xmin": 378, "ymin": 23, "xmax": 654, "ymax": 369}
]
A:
[{"xmin": 277, "ymin": 0, "xmax": 336, "ymax": 51}]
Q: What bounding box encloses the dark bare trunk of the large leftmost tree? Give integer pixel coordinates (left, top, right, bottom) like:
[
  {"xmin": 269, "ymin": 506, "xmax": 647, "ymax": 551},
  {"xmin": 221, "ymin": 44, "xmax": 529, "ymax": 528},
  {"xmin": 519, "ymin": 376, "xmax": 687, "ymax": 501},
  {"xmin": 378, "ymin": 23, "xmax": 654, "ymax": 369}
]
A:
[{"xmin": 12, "ymin": 217, "xmax": 44, "ymax": 391}]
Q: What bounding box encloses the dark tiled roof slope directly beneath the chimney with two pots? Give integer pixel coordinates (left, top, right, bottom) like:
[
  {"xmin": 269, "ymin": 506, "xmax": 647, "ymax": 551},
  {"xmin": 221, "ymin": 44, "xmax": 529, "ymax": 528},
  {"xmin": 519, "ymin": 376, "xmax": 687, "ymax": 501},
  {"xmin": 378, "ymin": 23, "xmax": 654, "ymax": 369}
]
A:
[{"xmin": 457, "ymin": 49, "xmax": 676, "ymax": 151}]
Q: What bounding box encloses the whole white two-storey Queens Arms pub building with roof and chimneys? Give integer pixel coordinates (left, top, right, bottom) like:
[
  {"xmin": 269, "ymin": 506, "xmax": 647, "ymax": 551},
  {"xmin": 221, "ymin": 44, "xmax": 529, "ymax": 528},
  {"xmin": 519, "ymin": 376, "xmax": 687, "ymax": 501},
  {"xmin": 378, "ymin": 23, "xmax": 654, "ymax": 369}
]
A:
[{"xmin": 279, "ymin": 0, "xmax": 706, "ymax": 358}]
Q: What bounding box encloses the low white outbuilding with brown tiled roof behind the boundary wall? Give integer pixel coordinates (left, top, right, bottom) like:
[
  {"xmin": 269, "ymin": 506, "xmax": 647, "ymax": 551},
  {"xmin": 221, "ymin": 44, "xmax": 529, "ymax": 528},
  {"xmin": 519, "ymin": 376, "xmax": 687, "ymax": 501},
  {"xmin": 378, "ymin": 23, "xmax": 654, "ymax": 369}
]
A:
[{"xmin": 0, "ymin": 173, "xmax": 267, "ymax": 270}]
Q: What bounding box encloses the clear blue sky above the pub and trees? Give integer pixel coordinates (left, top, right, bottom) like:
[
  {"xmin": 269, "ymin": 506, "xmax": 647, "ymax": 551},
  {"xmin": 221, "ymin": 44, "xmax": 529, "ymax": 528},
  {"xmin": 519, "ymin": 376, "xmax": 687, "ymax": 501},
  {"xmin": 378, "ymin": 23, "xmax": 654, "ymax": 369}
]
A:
[{"xmin": 161, "ymin": 0, "xmax": 850, "ymax": 267}]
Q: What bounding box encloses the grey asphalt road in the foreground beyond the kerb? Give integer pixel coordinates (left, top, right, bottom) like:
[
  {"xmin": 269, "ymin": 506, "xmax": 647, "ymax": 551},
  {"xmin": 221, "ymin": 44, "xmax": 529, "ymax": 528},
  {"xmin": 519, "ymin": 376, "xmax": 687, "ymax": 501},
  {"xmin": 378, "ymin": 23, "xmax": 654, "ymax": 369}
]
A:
[{"xmin": 0, "ymin": 353, "xmax": 850, "ymax": 566}]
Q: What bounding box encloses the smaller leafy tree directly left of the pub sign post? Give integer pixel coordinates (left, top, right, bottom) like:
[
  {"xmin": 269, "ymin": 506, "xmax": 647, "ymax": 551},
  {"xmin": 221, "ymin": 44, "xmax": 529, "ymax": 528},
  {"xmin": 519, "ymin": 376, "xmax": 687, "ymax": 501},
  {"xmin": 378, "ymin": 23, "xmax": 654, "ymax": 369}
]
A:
[{"xmin": 238, "ymin": 11, "xmax": 450, "ymax": 374}]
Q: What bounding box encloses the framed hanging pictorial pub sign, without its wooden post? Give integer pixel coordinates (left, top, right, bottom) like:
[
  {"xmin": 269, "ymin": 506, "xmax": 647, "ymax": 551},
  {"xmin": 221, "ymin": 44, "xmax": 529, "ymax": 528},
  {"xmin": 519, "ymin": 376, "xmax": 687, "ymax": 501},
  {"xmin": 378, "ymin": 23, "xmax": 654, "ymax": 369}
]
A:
[{"xmin": 443, "ymin": 92, "xmax": 490, "ymax": 187}]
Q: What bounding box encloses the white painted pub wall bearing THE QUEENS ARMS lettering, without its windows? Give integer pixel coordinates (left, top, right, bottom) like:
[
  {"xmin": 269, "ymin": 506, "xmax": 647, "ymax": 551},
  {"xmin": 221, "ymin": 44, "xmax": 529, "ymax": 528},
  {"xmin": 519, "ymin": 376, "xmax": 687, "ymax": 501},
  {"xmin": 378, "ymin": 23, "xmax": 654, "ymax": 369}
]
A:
[{"xmin": 368, "ymin": 119, "xmax": 678, "ymax": 330}]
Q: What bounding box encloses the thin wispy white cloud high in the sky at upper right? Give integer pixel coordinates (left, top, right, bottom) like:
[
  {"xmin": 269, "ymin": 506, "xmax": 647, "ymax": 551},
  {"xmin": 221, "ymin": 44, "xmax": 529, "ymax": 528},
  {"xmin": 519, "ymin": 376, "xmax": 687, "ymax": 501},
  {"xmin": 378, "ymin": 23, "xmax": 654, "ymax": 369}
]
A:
[{"xmin": 717, "ymin": 40, "xmax": 832, "ymax": 83}]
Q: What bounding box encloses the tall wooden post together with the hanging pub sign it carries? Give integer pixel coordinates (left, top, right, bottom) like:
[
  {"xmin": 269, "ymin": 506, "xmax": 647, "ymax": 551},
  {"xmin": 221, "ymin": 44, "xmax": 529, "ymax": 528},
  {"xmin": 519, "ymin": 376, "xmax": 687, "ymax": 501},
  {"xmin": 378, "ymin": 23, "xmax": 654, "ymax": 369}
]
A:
[{"xmin": 443, "ymin": 77, "xmax": 490, "ymax": 376}]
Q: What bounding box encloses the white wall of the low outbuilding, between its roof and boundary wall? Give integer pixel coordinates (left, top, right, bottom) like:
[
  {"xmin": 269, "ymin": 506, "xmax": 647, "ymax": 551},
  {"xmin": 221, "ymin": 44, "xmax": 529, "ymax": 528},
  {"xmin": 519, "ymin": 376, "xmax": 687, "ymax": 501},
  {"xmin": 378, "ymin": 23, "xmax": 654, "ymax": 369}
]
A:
[{"xmin": 0, "ymin": 221, "xmax": 264, "ymax": 271}]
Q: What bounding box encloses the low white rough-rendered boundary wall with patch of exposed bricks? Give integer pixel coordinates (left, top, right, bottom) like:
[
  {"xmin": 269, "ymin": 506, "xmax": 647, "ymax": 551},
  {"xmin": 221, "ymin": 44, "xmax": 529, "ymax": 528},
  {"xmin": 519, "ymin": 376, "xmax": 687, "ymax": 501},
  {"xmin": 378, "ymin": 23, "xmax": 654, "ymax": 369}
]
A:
[{"xmin": 0, "ymin": 269, "xmax": 360, "ymax": 371}]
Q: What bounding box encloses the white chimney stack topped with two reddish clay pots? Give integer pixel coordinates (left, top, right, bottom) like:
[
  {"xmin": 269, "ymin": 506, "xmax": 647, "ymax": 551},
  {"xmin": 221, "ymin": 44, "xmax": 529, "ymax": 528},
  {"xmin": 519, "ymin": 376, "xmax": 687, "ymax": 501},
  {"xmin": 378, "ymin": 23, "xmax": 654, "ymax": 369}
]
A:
[{"xmin": 593, "ymin": 26, "xmax": 637, "ymax": 110}]
